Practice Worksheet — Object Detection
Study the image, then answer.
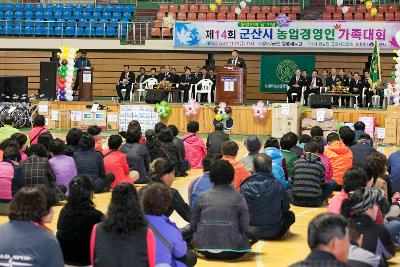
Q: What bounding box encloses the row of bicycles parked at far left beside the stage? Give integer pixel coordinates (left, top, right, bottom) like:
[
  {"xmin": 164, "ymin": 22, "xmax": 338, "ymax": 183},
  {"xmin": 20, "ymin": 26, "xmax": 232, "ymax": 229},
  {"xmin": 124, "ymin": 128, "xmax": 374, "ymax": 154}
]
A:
[{"xmin": 0, "ymin": 94, "xmax": 43, "ymax": 128}]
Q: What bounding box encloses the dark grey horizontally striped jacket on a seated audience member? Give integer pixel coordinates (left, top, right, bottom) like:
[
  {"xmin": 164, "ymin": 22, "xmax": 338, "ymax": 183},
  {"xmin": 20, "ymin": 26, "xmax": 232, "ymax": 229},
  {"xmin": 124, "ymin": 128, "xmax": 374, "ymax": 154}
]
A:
[{"xmin": 292, "ymin": 153, "xmax": 325, "ymax": 200}]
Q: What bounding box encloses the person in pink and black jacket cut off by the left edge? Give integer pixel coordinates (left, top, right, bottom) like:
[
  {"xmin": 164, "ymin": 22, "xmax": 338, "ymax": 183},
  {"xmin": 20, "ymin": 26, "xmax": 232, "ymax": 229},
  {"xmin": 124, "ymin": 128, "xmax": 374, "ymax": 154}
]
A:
[{"xmin": 0, "ymin": 145, "xmax": 25, "ymax": 215}]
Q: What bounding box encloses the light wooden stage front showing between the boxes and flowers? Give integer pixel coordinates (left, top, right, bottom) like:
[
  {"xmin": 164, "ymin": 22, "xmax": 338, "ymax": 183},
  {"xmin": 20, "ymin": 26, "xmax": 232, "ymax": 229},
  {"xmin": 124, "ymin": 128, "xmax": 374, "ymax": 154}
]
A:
[{"xmin": 41, "ymin": 101, "xmax": 388, "ymax": 135}]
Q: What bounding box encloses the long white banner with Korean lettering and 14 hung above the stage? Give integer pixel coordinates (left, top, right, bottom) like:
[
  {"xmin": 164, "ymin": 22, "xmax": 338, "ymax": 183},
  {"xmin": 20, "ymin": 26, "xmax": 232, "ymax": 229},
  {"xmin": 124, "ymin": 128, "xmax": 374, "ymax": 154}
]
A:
[{"xmin": 174, "ymin": 19, "xmax": 400, "ymax": 49}]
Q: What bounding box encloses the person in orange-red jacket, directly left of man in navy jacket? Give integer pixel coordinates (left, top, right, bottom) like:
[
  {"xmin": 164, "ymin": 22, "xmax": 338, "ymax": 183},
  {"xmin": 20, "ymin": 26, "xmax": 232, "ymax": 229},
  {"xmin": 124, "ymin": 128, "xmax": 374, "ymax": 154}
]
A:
[{"xmin": 221, "ymin": 141, "xmax": 250, "ymax": 190}]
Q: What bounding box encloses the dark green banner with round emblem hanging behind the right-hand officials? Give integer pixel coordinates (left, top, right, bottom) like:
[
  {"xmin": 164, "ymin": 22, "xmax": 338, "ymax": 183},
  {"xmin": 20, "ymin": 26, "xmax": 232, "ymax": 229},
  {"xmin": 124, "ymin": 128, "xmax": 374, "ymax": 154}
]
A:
[{"xmin": 260, "ymin": 55, "xmax": 315, "ymax": 93}]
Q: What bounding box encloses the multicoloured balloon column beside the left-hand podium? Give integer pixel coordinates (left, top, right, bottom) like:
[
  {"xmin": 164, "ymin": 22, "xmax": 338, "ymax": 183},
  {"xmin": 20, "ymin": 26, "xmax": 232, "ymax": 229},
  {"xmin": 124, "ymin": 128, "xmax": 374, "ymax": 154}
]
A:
[{"xmin": 56, "ymin": 46, "xmax": 78, "ymax": 101}]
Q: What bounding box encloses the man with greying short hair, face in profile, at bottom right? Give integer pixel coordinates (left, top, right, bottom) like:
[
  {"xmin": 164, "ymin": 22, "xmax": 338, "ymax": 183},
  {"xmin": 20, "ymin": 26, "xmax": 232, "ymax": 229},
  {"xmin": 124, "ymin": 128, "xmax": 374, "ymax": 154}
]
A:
[{"xmin": 291, "ymin": 213, "xmax": 350, "ymax": 267}]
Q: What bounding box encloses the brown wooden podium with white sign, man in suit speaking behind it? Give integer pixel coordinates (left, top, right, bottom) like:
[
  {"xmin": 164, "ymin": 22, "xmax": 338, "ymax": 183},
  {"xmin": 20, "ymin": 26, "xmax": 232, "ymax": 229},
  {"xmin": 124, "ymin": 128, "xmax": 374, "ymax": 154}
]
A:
[{"xmin": 215, "ymin": 65, "xmax": 247, "ymax": 105}]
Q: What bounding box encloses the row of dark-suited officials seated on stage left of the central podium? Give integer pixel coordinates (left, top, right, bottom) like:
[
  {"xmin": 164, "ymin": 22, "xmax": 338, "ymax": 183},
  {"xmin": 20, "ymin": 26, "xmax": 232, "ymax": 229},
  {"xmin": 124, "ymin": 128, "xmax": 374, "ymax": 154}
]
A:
[{"xmin": 116, "ymin": 65, "xmax": 216, "ymax": 102}]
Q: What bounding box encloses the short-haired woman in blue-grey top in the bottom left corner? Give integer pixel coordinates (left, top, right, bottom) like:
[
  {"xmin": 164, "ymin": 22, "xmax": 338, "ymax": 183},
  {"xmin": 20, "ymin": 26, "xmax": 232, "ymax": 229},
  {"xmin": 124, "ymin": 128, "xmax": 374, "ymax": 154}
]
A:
[{"xmin": 0, "ymin": 187, "xmax": 64, "ymax": 267}]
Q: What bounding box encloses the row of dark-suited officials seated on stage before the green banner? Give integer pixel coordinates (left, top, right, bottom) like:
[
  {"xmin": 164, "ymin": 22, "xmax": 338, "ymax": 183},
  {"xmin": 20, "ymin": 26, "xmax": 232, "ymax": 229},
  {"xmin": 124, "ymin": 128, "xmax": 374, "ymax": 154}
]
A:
[{"xmin": 287, "ymin": 68, "xmax": 383, "ymax": 105}]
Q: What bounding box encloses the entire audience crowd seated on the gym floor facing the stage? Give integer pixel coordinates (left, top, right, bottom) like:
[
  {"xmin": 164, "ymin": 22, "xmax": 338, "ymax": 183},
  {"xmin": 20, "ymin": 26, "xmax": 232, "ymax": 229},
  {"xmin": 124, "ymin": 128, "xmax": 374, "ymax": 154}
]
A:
[{"xmin": 0, "ymin": 116, "xmax": 400, "ymax": 267}]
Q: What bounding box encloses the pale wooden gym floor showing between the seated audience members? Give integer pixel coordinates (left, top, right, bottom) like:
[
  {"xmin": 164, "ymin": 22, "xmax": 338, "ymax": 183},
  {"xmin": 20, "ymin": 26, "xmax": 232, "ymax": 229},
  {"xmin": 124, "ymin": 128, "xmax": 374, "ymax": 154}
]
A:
[{"xmin": 0, "ymin": 134, "xmax": 400, "ymax": 267}]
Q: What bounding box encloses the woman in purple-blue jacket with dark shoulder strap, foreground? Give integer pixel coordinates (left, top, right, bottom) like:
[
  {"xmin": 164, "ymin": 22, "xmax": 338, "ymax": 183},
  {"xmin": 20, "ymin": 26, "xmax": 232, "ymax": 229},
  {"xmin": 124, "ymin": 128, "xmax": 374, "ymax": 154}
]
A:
[{"xmin": 142, "ymin": 183, "xmax": 197, "ymax": 267}]
